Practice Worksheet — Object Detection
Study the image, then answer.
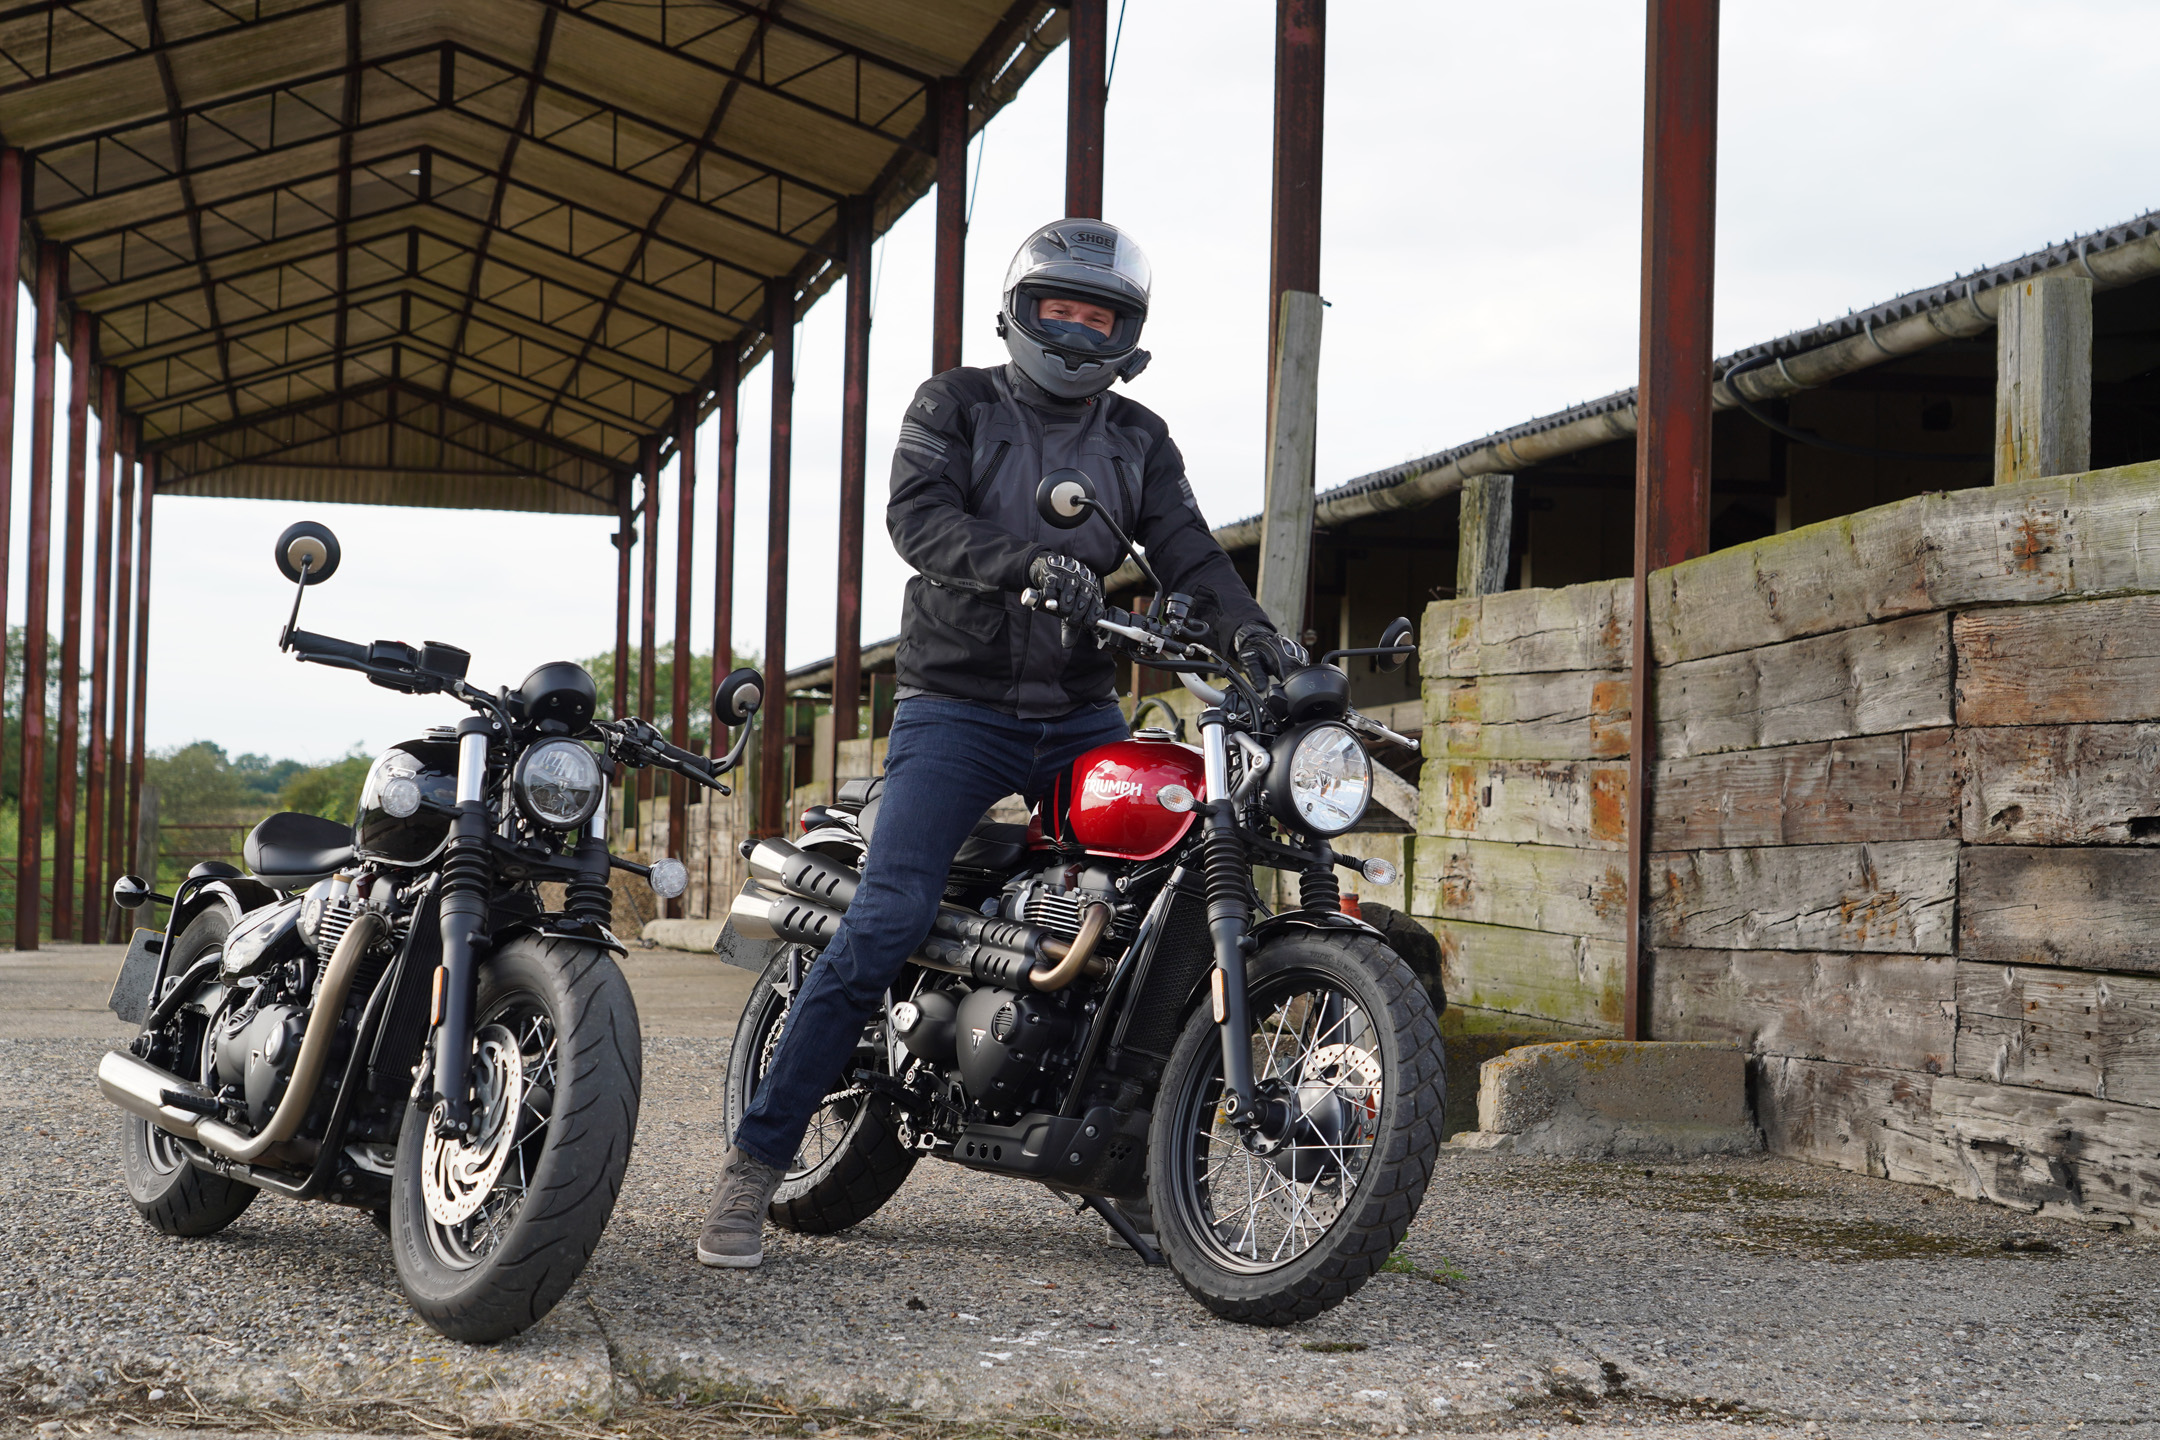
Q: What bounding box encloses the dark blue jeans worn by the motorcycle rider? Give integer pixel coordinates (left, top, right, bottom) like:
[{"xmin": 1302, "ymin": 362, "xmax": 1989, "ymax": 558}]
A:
[{"xmin": 734, "ymin": 695, "xmax": 1128, "ymax": 1170}]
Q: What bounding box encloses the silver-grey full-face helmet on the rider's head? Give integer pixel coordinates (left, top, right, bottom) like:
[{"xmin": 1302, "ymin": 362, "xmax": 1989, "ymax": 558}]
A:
[{"xmin": 998, "ymin": 218, "xmax": 1153, "ymax": 399}]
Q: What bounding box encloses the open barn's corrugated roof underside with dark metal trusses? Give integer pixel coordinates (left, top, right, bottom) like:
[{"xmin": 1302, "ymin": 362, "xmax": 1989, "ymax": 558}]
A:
[{"xmin": 0, "ymin": 0, "xmax": 1065, "ymax": 512}]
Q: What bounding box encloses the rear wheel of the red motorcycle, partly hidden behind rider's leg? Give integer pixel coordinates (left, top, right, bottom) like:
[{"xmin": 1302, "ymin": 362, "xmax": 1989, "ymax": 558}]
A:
[{"xmin": 724, "ymin": 948, "xmax": 916, "ymax": 1235}]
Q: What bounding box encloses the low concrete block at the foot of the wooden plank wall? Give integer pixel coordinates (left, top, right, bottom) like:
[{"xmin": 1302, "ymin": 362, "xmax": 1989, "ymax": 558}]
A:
[{"xmin": 1449, "ymin": 1041, "xmax": 1763, "ymax": 1159}]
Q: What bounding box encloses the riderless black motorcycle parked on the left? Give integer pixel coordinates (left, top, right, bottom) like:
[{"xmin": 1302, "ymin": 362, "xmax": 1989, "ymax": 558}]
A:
[{"xmin": 97, "ymin": 522, "xmax": 760, "ymax": 1341}]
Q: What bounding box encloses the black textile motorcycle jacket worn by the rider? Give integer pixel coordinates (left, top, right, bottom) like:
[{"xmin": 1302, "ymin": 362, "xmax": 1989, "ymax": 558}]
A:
[{"xmin": 886, "ymin": 365, "xmax": 1268, "ymax": 719}]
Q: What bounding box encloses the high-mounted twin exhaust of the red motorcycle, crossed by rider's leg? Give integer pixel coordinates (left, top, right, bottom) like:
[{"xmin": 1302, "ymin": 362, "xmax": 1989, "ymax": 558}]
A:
[{"xmin": 728, "ymin": 838, "xmax": 1110, "ymax": 991}]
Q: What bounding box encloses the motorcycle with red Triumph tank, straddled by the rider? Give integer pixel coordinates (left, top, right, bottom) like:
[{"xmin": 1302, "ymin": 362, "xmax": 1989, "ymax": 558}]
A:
[{"xmin": 717, "ymin": 471, "xmax": 1445, "ymax": 1326}]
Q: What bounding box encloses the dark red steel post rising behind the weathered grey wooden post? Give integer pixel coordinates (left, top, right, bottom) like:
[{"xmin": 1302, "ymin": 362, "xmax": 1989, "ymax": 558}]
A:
[{"xmin": 1266, "ymin": 0, "xmax": 1328, "ymax": 397}]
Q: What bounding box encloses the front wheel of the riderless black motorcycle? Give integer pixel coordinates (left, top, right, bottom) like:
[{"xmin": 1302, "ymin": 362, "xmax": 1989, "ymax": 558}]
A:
[{"xmin": 391, "ymin": 937, "xmax": 642, "ymax": 1343}]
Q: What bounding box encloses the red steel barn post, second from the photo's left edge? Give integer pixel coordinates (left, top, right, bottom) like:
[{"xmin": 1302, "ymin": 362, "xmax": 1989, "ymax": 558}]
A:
[{"xmin": 15, "ymin": 240, "xmax": 67, "ymax": 950}]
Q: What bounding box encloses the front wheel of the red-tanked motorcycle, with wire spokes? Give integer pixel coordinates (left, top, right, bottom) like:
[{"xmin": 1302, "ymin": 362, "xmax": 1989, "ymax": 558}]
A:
[{"xmin": 1149, "ymin": 930, "xmax": 1445, "ymax": 1326}]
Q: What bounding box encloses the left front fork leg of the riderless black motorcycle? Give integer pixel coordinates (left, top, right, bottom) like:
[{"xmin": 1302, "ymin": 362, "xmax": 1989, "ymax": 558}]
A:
[{"xmin": 432, "ymin": 715, "xmax": 497, "ymax": 1140}]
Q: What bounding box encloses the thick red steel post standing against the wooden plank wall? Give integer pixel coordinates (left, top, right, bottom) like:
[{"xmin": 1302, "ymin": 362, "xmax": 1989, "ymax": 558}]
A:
[{"xmin": 1620, "ymin": 0, "xmax": 1717, "ymax": 1041}]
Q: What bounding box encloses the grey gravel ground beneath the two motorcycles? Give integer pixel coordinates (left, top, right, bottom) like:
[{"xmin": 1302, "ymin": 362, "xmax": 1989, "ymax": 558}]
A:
[{"xmin": 0, "ymin": 1038, "xmax": 2160, "ymax": 1438}]
